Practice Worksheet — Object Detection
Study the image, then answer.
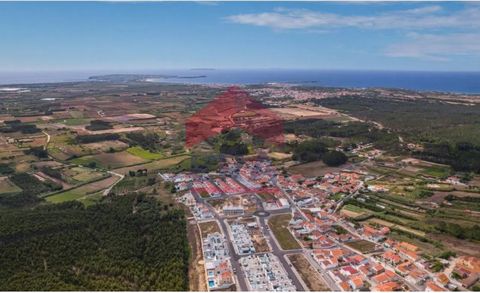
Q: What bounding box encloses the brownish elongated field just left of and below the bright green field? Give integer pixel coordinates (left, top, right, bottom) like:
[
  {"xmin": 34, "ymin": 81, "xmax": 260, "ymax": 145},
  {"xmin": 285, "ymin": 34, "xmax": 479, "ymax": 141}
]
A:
[{"xmin": 72, "ymin": 152, "xmax": 147, "ymax": 169}]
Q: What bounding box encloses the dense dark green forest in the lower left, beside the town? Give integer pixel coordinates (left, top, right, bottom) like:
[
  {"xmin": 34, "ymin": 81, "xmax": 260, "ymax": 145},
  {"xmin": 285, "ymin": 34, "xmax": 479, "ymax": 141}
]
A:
[{"xmin": 0, "ymin": 195, "xmax": 189, "ymax": 291}]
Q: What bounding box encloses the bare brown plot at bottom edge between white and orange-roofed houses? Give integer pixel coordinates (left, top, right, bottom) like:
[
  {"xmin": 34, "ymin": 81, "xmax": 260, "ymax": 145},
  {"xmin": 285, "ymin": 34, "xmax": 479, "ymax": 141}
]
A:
[{"xmin": 288, "ymin": 254, "xmax": 330, "ymax": 291}]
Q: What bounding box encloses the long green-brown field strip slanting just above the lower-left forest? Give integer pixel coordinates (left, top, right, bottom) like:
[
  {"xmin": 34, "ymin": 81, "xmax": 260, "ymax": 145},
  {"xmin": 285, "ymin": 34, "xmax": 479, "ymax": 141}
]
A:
[{"xmin": 45, "ymin": 176, "xmax": 119, "ymax": 203}]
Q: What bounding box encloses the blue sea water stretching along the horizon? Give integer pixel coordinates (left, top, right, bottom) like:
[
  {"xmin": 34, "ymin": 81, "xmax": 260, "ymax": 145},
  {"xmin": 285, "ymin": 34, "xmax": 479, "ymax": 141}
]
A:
[{"xmin": 0, "ymin": 69, "xmax": 480, "ymax": 94}]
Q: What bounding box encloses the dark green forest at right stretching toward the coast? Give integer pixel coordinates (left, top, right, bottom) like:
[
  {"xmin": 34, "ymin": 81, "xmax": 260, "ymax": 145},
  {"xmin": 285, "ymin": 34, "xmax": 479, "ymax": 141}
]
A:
[{"xmin": 315, "ymin": 97, "xmax": 480, "ymax": 173}]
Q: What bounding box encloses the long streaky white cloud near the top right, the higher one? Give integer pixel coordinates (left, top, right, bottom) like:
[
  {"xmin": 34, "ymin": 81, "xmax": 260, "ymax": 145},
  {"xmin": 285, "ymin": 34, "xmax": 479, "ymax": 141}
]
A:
[{"xmin": 227, "ymin": 5, "xmax": 480, "ymax": 29}]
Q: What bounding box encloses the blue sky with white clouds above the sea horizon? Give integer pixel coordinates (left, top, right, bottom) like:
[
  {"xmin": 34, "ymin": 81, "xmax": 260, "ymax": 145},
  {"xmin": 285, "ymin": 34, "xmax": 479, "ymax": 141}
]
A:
[{"xmin": 0, "ymin": 2, "xmax": 480, "ymax": 71}]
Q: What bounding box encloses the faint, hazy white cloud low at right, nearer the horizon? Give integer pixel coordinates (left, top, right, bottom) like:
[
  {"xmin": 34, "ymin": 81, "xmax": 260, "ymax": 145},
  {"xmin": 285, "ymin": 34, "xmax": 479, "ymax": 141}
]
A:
[{"xmin": 385, "ymin": 33, "xmax": 480, "ymax": 61}]
